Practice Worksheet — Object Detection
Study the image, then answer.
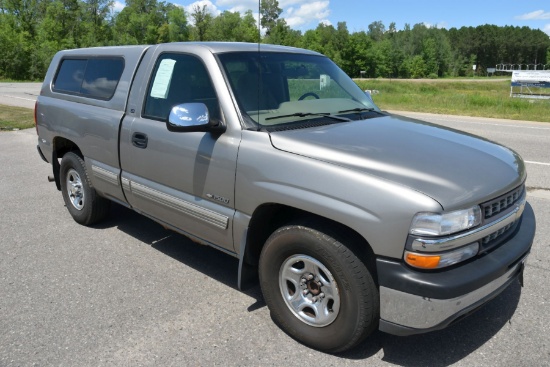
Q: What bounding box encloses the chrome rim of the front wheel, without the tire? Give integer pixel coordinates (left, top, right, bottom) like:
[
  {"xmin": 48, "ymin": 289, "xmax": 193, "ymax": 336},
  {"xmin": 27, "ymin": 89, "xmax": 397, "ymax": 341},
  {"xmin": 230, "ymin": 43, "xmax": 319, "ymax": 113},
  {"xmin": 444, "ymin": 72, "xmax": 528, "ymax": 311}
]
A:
[{"xmin": 279, "ymin": 255, "xmax": 340, "ymax": 327}]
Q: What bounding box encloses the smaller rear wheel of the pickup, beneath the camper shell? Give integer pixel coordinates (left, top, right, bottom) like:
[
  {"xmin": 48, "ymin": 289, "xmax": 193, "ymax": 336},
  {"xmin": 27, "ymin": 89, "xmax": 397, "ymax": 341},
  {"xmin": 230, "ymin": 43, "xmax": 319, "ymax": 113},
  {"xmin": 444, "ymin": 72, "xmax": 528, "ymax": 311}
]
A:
[{"xmin": 60, "ymin": 153, "xmax": 111, "ymax": 226}]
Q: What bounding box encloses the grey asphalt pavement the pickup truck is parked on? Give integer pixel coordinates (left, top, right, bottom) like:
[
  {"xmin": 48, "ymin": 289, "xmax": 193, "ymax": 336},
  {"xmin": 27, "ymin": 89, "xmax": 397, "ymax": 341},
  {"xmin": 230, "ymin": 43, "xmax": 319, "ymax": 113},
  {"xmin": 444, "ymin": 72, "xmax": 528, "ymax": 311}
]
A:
[{"xmin": 0, "ymin": 85, "xmax": 550, "ymax": 367}]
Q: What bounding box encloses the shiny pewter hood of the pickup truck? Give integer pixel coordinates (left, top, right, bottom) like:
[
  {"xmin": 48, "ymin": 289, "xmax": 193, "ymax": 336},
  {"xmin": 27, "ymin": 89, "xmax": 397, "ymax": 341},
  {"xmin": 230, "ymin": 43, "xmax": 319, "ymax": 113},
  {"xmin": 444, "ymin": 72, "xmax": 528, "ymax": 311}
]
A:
[{"xmin": 270, "ymin": 116, "xmax": 525, "ymax": 209}]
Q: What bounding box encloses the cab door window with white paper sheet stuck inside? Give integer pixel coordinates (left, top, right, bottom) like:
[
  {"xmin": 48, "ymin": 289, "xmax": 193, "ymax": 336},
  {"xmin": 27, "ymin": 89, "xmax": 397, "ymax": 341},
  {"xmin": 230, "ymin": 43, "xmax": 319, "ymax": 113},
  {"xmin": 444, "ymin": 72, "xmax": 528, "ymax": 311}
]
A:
[{"xmin": 143, "ymin": 53, "xmax": 220, "ymax": 120}]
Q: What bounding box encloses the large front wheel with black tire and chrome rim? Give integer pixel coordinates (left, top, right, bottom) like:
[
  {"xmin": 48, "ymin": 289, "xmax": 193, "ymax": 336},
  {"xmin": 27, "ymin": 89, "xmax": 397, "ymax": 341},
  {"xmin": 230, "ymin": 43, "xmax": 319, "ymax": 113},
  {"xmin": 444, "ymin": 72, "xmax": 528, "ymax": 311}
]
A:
[{"xmin": 259, "ymin": 221, "xmax": 379, "ymax": 353}]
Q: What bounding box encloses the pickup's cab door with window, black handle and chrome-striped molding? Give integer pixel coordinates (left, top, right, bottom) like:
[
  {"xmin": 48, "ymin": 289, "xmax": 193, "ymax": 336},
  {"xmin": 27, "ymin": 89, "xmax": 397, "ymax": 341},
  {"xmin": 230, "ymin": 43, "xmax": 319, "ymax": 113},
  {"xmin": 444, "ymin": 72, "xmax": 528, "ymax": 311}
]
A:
[{"xmin": 120, "ymin": 53, "xmax": 240, "ymax": 252}]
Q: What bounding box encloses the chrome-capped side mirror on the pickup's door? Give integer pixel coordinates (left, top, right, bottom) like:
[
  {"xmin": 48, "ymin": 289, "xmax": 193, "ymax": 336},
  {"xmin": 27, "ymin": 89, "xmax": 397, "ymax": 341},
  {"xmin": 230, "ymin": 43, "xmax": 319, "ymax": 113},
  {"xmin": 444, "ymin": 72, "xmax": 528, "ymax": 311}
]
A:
[{"xmin": 166, "ymin": 103, "xmax": 225, "ymax": 134}]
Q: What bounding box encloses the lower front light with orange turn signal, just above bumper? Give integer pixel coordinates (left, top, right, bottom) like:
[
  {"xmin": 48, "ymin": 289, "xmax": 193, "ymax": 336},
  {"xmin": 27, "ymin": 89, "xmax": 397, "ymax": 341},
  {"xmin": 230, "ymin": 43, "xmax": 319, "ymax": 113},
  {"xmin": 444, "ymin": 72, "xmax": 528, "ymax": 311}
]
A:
[{"xmin": 405, "ymin": 242, "xmax": 479, "ymax": 269}]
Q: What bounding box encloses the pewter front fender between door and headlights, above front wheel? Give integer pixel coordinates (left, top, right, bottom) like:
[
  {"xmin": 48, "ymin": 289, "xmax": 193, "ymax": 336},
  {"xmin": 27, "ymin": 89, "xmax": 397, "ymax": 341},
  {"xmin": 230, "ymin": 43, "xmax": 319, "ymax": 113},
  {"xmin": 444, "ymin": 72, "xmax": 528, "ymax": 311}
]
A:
[{"xmin": 235, "ymin": 131, "xmax": 441, "ymax": 258}]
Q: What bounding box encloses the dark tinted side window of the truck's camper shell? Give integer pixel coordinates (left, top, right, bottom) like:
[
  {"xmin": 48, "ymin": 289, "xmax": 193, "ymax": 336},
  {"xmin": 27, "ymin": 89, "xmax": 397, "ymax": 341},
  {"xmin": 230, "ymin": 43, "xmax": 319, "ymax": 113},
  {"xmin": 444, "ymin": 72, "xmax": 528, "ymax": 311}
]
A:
[{"xmin": 53, "ymin": 58, "xmax": 124, "ymax": 100}]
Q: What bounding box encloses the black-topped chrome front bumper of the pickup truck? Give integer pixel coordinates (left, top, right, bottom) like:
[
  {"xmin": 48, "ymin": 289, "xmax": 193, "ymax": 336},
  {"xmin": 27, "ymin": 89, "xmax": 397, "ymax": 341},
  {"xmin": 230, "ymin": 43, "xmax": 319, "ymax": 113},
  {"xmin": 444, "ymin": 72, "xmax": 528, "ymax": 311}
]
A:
[{"xmin": 377, "ymin": 204, "xmax": 536, "ymax": 335}]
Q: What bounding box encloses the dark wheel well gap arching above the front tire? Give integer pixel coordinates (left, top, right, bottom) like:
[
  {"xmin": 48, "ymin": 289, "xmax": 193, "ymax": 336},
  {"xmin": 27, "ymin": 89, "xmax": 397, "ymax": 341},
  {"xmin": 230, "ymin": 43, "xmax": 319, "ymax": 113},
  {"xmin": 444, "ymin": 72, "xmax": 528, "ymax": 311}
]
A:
[{"xmin": 243, "ymin": 204, "xmax": 378, "ymax": 284}]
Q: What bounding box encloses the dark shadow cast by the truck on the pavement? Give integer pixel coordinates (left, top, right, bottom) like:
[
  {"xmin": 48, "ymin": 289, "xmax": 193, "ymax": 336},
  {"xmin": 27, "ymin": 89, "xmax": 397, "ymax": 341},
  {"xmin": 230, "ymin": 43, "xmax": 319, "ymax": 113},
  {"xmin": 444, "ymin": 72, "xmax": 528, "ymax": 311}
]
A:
[{"xmin": 94, "ymin": 205, "xmax": 521, "ymax": 366}]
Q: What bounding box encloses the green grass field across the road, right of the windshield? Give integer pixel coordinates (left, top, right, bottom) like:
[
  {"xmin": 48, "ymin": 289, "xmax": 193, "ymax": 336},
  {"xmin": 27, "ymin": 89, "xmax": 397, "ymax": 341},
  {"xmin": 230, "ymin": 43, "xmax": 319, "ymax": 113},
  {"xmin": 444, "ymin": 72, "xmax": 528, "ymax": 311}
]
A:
[{"xmin": 356, "ymin": 80, "xmax": 550, "ymax": 122}]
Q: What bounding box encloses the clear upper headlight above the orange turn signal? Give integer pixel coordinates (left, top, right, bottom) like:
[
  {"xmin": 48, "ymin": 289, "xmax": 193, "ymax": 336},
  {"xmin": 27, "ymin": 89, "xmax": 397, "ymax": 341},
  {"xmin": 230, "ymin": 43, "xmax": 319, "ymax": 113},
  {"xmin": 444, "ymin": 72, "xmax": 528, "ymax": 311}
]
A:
[{"xmin": 410, "ymin": 205, "xmax": 481, "ymax": 236}]
